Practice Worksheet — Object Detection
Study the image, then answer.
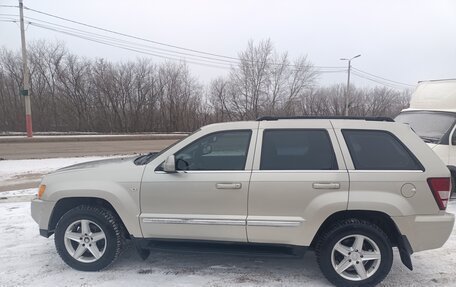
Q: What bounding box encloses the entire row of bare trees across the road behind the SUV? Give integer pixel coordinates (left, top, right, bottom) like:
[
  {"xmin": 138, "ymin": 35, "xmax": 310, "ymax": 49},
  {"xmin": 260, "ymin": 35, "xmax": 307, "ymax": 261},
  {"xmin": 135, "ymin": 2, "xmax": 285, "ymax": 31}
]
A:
[{"xmin": 0, "ymin": 40, "xmax": 408, "ymax": 133}]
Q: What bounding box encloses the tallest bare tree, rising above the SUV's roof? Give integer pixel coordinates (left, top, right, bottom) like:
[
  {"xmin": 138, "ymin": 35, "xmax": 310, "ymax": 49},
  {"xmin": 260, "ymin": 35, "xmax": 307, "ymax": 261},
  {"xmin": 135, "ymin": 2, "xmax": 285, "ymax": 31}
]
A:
[{"xmin": 209, "ymin": 40, "xmax": 317, "ymax": 120}]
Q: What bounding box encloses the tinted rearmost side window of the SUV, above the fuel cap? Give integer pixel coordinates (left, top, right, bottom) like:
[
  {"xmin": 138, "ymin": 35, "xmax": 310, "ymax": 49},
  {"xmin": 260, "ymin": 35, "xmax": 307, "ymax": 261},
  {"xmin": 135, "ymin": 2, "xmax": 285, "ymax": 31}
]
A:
[{"xmin": 342, "ymin": 130, "xmax": 423, "ymax": 170}]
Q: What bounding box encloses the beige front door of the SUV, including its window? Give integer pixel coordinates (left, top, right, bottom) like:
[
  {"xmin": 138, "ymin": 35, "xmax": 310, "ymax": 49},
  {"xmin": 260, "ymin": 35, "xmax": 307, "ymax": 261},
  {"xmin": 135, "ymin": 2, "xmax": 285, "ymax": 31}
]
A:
[{"xmin": 140, "ymin": 127, "xmax": 257, "ymax": 242}]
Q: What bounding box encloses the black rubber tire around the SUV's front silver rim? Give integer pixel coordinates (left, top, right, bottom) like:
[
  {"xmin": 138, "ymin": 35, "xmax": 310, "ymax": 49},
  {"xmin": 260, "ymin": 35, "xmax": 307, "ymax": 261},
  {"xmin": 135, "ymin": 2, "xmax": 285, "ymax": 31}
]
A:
[{"xmin": 54, "ymin": 205, "xmax": 123, "ymax": 271}]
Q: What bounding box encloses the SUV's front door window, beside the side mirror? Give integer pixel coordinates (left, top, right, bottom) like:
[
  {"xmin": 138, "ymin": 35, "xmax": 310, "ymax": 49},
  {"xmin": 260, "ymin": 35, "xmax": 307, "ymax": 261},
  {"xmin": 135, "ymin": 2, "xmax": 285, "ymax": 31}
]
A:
[{"xmin": 175, "ymin": 130, "xmax": 251, "ymax": 170}]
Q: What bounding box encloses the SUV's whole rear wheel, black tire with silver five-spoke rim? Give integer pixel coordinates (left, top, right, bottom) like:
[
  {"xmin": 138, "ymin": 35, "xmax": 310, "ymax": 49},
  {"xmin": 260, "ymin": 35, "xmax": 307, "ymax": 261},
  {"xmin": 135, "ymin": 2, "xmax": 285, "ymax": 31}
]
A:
[{"xmin": 317, "ymin": 219, "xmax": 393, "ymax": 286}]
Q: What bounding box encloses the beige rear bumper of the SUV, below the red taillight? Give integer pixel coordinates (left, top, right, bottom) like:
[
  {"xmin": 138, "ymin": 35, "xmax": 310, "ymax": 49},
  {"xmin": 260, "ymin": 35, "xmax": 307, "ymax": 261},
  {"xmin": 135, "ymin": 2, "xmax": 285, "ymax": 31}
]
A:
[{"xmin": 392, "ymin": 213, "xmax": 454, "ymax": 252}]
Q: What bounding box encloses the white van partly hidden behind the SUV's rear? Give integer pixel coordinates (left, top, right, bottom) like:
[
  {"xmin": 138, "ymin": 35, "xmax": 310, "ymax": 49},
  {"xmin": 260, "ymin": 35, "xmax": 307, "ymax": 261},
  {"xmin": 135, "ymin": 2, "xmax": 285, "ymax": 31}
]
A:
[{"xmin": 395, "ymin": 79, "xmax": 456, "ymax": 190}]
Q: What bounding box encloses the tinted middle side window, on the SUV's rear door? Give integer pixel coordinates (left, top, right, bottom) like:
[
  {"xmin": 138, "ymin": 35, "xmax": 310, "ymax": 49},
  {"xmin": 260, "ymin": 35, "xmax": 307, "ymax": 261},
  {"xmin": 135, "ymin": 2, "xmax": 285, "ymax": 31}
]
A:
[{"xmin": 260, "ymin": 129, "xmax": 337, "ymax": 170}]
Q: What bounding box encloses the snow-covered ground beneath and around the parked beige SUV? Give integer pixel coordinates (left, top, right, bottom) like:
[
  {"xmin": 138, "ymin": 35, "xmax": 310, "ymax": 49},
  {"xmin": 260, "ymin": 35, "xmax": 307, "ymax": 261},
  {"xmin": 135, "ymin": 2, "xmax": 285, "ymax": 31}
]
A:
[{"xmin": 0, "ymin": 202, "xmax": 456, "ymax": 286}]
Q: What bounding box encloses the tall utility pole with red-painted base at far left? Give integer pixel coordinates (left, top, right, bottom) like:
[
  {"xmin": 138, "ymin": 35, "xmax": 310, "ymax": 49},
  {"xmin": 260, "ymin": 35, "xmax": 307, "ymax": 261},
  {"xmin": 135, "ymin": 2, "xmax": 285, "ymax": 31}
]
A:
[{"xmin": 19, "ymin": 0, "xmax": 33, "ymax": 138}]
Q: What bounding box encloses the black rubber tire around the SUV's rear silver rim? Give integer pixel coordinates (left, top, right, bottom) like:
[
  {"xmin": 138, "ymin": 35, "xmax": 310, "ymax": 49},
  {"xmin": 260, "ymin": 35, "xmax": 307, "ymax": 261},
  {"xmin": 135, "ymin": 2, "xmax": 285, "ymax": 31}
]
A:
[{"xmin": 316, "ymin": 219, "xmax": 393, "ymax": 287}]
